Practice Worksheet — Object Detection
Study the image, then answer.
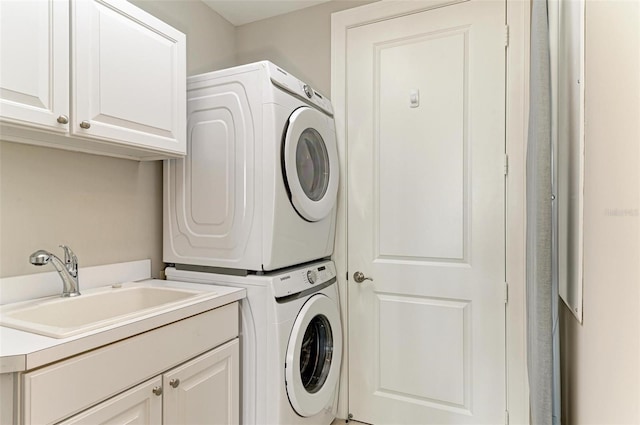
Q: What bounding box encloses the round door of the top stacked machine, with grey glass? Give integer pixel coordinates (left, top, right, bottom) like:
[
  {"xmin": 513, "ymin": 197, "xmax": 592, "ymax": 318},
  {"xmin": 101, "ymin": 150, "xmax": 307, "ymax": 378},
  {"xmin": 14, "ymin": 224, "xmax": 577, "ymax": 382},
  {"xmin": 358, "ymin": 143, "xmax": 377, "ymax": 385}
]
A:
[{"xmin": 283, "ymin": 106, "xmax": 339, "ymax": 221}]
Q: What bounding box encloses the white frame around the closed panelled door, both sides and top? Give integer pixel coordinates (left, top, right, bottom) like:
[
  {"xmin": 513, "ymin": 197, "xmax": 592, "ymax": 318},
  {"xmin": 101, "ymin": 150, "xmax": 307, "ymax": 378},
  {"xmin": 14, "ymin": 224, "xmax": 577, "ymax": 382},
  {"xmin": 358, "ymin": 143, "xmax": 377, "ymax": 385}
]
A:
[{"xmin": 331, "ymin": 0, "xmax": 530, "ymax": 424}]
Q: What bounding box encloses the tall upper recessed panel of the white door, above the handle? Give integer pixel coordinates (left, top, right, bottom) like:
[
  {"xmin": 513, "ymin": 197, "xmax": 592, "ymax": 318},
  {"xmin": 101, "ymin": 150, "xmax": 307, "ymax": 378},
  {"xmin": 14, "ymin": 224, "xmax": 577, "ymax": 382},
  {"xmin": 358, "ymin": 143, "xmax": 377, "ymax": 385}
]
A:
[{"xmin": 373, "ymin": 25, "xmax": 470, "ymax": 263}]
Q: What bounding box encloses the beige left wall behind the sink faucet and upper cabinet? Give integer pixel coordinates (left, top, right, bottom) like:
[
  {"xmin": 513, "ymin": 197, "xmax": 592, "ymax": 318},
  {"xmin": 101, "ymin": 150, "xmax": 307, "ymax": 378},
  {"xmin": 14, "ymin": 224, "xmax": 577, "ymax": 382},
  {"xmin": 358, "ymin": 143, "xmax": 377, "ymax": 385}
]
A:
[{"xmin": 0, "ymin": 0, "xmax": 235, "ymax": 277}]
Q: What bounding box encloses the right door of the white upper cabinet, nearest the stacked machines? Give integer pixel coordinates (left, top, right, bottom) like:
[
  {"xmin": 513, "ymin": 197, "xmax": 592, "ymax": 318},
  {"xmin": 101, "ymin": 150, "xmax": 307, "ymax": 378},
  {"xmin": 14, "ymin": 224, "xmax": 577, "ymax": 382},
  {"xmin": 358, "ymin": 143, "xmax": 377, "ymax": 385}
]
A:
[{"xmin": 74, "ymin": 0, "xmax": 186, "ymax": 154}]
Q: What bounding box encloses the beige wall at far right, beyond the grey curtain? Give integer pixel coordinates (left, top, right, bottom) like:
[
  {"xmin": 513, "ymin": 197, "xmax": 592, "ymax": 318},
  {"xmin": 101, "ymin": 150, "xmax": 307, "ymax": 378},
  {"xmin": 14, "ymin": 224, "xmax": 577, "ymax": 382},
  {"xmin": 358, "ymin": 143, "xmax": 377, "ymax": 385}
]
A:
[{"xmin": 561, "ymin": 1, "xmax": 640, "ymax": 424}]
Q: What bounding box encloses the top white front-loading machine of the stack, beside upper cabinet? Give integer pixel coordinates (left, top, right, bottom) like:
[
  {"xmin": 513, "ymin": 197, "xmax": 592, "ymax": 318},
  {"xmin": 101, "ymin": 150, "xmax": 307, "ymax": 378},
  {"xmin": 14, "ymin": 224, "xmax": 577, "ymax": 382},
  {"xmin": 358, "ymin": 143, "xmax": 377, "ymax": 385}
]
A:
[{"xmin": 163, "ymin": 61, "xmax": 339, "ymax": 271}]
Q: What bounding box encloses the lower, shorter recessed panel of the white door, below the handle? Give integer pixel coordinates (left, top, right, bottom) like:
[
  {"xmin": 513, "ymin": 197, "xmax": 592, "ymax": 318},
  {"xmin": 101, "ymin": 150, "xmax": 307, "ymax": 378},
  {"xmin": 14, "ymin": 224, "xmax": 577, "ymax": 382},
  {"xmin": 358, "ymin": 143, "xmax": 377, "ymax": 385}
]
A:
[{"xmin": 375, "ymin": 291, "xmax": 471, "ymax": 415}]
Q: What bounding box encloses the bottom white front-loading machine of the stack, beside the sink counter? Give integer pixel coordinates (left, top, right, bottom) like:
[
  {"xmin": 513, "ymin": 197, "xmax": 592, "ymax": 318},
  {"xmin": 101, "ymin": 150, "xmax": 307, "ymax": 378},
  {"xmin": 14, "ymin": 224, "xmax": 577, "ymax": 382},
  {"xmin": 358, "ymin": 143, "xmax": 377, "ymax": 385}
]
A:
[{"xmin": 165, "ymin": 261, "xmax": 342, "ymax": 425}]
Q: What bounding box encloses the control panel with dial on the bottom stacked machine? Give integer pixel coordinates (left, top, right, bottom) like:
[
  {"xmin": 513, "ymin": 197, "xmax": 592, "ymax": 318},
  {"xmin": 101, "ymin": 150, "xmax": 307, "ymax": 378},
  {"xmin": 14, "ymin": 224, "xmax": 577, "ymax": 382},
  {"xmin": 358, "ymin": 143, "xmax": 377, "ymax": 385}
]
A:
[{"xmin": 271, "ymin": 261, "xmax": 336, "ymax": 298}]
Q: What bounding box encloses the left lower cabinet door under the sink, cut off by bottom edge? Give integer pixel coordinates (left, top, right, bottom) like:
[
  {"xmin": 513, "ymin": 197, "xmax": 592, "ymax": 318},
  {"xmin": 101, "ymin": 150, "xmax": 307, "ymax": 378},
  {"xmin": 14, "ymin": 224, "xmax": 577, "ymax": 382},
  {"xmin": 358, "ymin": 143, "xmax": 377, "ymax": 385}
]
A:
[{"xmin": 60, "ymin": 376, "xmax": 162, "ymax": 425}]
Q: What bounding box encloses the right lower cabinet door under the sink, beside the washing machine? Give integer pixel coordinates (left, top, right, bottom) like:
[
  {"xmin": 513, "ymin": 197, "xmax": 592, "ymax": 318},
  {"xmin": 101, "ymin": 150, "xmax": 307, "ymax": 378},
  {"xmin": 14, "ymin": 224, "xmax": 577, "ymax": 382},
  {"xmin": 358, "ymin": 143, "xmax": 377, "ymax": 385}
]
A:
[{"xmin": 163, "ymin": 338, "xmax": 240, "ymax": 425}]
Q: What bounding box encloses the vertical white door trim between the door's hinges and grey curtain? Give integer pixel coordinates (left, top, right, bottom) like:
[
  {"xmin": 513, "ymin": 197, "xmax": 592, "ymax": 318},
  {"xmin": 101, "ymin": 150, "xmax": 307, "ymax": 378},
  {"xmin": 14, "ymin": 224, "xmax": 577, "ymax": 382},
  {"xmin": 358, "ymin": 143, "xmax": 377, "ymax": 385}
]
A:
[{"xmin": 506, "ymin": 1, "xmax": 531, "ymax": 424}]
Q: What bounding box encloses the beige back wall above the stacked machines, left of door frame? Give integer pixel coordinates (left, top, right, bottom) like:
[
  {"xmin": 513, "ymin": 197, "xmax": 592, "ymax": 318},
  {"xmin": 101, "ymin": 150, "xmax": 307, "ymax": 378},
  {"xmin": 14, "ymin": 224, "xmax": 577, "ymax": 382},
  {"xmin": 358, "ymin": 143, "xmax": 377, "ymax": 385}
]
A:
[{"xmin": 236, "ymin": 0, "xmax": 372, "ymax": 96}]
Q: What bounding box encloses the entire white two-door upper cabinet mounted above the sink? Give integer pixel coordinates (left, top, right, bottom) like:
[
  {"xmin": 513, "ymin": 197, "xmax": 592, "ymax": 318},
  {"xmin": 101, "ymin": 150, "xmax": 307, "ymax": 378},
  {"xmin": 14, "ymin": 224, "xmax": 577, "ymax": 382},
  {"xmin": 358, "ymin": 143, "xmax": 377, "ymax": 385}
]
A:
[{"xmin": 0, "ymin": 0, "xmax": 186, "ymax": 159}]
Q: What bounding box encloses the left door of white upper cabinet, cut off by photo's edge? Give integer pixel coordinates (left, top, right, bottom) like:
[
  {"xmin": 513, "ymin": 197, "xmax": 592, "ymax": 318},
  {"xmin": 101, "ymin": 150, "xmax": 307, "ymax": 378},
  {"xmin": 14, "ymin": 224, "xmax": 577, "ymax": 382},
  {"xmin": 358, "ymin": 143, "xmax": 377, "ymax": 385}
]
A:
[{"xmin": 0, "ymin": 0, "xmax": 69, "ymax": 132}]
